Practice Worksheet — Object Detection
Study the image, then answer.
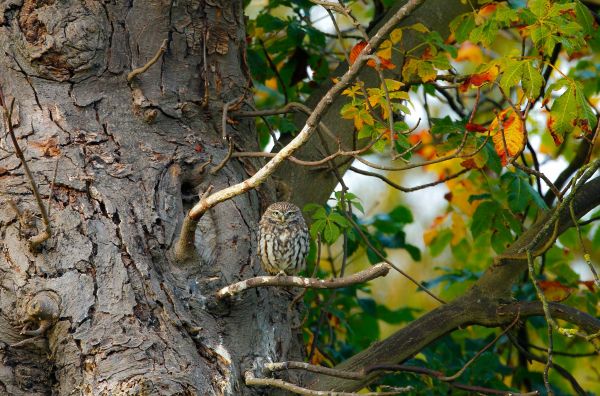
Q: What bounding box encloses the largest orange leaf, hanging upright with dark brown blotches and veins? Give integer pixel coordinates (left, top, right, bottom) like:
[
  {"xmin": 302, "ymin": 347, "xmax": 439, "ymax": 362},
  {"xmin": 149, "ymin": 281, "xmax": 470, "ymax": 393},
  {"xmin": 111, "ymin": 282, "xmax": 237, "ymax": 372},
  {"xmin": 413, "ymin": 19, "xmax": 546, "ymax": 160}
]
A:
[{"xmin": 490, "ymin": 108, "xmax": 527, "ymax": 166}]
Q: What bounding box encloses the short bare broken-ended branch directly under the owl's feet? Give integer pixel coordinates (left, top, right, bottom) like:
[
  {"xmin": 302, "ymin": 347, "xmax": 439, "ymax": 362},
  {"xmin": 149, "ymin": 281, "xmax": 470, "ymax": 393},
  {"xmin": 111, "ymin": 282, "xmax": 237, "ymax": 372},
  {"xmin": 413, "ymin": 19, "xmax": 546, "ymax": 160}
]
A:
[{"xmin": 217, "ymin": 263, "xmax": 391, "ymax": 300}]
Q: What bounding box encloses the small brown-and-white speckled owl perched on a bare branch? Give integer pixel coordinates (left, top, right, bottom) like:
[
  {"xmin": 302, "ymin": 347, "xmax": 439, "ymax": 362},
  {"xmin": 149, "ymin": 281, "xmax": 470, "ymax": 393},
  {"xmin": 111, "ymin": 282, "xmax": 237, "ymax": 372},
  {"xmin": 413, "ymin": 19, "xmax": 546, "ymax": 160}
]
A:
[{"xmin": 258, "ymin": 202, "xmax": 309, "ymax": 275}]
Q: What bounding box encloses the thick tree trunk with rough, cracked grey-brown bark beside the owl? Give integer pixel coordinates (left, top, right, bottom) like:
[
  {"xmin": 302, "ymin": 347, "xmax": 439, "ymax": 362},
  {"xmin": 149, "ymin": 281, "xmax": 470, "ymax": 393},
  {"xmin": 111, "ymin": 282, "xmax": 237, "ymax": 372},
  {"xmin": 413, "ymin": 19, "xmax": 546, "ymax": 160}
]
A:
[{"xmin": 0, "ymin": 0, "xmax": 301, "ymax": 395}]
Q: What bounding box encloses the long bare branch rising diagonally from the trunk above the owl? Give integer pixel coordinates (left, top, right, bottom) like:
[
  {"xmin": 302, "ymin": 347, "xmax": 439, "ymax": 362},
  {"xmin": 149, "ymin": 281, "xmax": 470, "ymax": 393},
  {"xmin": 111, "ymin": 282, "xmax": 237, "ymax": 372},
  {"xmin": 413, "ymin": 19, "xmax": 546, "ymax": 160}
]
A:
[{"xmin": 175, "ymin": 0, "xmax": 424, "ymax": 260}]
